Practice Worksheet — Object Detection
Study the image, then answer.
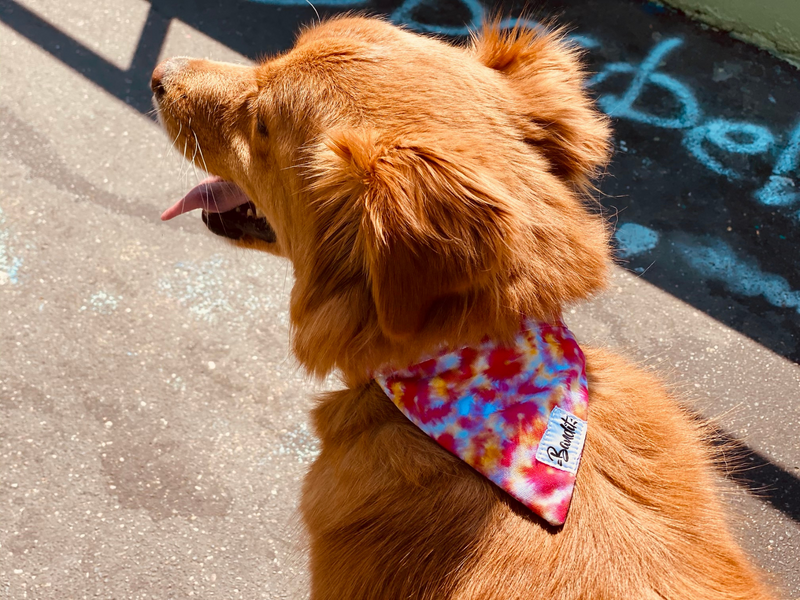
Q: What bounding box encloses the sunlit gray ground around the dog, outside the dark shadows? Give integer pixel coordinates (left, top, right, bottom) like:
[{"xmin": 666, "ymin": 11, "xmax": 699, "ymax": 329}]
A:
[{"xmin": 0, "ymin": 0, "xmax": 800, "ymax": 600}]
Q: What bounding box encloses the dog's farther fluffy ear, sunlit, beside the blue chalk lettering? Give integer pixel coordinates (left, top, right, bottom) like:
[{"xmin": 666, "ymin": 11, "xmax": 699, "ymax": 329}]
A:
[{"xmin": 472, "ymin": 21, "xmax": 611, "ymax": 188}]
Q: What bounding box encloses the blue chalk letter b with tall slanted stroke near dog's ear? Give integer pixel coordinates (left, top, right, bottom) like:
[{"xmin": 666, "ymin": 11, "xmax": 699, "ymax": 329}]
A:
[{"xmin": 590, "ymin": 38, "xmax": 701, "ymax": 129}]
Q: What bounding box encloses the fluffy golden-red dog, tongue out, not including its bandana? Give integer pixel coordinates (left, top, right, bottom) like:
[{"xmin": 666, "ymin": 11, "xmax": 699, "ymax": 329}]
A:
[{"xmin": 152, "ymin": 16, "xmax": 775, "ymax": 600}]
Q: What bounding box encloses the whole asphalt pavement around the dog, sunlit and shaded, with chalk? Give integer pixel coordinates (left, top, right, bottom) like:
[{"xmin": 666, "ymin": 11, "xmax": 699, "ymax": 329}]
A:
[{"xmin": 0, "ymin": 0, "xmax": 800, "ymax": 600}]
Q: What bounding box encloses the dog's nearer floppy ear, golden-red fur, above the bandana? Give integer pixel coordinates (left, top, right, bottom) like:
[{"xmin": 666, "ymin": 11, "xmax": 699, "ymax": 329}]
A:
[{"xmin": 306, "ymin": 131, "xmax": 512, "ymax": 340}]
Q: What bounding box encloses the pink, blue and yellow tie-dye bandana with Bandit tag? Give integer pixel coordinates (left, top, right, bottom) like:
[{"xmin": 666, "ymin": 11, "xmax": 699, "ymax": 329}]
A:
[{"xmin": 375, "ymin": 320, "xmax": 589, "ymax": 525}]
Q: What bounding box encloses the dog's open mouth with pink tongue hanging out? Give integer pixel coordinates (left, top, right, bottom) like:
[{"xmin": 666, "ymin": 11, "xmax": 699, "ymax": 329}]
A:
[{"xmin": 161, "ymin": 177, "xmax": 276, "ymax": 244}]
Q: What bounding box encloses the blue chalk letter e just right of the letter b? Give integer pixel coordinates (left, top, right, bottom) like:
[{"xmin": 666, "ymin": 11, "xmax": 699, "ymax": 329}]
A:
[{"xmin": 683, "ymin": 119, "xmax": 775, "ymax": 179}]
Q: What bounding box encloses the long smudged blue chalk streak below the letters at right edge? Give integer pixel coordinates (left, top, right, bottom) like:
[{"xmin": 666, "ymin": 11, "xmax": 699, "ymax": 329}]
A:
[{"xmin": 675, "ymin": 239, "xmax": 800, "ymax": 313}]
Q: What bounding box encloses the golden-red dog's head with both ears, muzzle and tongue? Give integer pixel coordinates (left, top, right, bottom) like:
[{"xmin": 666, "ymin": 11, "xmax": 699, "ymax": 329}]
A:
[{"xmin": 153, "ymin": 18, "xmax": 609, "ymax": 376}]
